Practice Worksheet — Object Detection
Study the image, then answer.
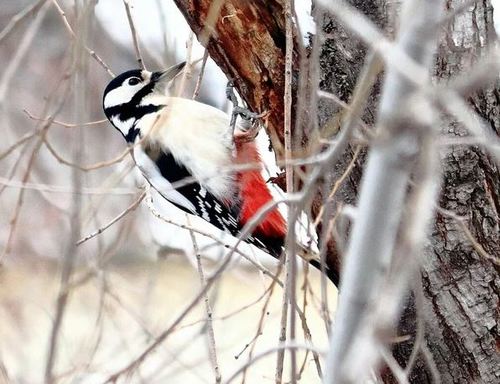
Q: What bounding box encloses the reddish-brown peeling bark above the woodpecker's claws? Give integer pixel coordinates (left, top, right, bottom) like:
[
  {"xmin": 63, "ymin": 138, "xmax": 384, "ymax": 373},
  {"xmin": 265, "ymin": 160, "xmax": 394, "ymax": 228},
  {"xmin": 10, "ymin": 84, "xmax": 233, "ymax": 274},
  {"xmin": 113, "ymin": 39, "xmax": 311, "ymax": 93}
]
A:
[{"xmin": 175, "ymin": 0, "xmax": 285, "ymax": 156}]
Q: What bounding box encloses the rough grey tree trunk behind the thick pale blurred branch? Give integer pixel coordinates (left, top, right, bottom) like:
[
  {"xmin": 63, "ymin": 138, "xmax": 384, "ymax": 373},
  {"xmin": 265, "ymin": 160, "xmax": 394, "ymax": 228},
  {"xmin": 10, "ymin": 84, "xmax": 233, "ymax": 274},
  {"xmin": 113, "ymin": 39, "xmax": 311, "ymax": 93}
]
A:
[{"xmin": 319, "ymin": 1, "xmax": 500, "ymax": 383}]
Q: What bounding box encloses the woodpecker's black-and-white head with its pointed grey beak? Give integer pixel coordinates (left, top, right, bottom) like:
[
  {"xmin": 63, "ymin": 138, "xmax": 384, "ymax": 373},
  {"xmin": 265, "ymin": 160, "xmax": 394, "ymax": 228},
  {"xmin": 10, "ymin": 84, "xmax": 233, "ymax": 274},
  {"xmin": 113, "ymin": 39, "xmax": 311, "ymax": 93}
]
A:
[{"xmin": 102, "ymin": 62, "xmax": 186, "ymax": 142}]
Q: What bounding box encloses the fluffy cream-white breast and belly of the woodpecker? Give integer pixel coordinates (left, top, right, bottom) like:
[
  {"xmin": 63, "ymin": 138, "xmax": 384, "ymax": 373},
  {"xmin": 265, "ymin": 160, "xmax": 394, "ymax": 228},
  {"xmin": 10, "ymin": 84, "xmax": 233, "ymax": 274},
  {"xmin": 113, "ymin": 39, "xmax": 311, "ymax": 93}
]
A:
[{"xmin": 138, "ymin": 98, "xmax": 237, "ymax": 201}]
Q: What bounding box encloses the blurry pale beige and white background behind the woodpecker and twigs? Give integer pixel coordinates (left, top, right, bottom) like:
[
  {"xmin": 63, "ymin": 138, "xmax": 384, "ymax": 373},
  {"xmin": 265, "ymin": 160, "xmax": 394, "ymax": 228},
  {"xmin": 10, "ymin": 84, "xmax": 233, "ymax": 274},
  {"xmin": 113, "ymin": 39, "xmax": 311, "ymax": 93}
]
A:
[{"xmin": 0, "ymin": 0, "xmax": 336, "ymax": 383}]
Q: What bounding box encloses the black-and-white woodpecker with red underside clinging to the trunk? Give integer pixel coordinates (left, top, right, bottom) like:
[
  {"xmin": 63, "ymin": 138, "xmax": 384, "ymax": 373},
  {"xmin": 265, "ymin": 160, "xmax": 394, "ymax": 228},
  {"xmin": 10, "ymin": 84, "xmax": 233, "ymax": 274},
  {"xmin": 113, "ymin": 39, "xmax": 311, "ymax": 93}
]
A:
[{"xmin": 103, "ymin": 62, "xmax": 336, "ymax": 284}]
